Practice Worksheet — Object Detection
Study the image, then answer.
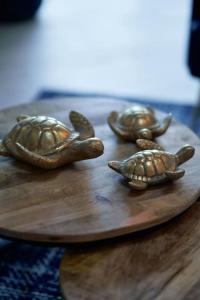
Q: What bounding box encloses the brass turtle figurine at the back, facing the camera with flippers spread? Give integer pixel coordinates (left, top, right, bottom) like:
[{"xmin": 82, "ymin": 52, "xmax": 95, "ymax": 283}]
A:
[{"xmin": 108, "ymin": 104, "xmax": 172, "ymax": 142}]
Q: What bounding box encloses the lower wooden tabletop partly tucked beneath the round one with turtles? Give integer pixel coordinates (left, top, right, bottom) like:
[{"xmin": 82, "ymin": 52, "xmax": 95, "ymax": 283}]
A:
[{"xmin": 60, "ymin": 202, "xmax": 200, "ymax": 300}]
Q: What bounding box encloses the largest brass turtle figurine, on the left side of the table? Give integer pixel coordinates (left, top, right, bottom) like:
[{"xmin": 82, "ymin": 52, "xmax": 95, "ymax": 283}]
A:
[{"xmin": 0, "ymin": 111, "xmax": 104, "ymax": 169}]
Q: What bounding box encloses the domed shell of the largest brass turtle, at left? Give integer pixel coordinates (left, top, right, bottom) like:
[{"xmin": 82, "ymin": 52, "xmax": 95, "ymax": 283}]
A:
[{"xmin": 4, "ymin": 116, "xmax": 79, "ymax": 155}]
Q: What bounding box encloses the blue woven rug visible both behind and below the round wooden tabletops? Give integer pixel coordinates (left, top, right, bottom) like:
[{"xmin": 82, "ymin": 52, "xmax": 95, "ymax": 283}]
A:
[{"xmin": 0, "ymin": 91, "xmax": 200, "ymax": 300}]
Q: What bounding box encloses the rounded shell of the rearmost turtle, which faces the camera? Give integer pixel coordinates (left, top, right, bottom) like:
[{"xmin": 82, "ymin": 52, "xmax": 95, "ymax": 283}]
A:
[{"xmin": 118, "ymin": 105, "xmax": 157, "ymax": 128}]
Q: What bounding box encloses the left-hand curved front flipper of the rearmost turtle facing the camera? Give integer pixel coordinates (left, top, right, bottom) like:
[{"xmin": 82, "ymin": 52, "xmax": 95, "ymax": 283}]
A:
[{"xmin": 108, "ymin": 111, "xmax": 133, "ymax": 141}]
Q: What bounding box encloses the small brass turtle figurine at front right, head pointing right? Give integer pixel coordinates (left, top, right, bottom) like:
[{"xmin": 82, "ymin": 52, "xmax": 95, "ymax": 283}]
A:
[{"xmin": 108, "ymin": 139, "xmax": 195, "ymax": 190}]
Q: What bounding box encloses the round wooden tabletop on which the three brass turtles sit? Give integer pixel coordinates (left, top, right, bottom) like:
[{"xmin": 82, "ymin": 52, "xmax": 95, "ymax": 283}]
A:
[{"xmin": 0, "ymin": 99, "xmax": 200, "ymax": 243}]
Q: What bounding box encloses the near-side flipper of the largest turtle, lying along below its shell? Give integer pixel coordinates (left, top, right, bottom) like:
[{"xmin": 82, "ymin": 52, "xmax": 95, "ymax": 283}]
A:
[{"xmin": 16, "ymin": 143, "xmax": 60, "ymax": 169}]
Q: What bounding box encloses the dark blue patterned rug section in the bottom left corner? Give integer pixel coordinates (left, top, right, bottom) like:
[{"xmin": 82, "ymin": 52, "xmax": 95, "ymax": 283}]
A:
[{"xmin": 0, "ymin": 239, "xmax": 64, "ymax": 300}]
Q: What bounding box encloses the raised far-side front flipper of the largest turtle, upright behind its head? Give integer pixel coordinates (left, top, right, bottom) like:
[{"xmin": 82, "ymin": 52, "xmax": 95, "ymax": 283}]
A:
[{"xmin": 69, "ymin": 111, "xmax": 95, "ymax": 140}]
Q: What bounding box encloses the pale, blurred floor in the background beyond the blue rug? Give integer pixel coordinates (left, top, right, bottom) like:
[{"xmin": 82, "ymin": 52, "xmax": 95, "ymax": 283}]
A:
[{"xmin": 0, "ymin": 0, "xmax": 198, "ymax": 108}]
